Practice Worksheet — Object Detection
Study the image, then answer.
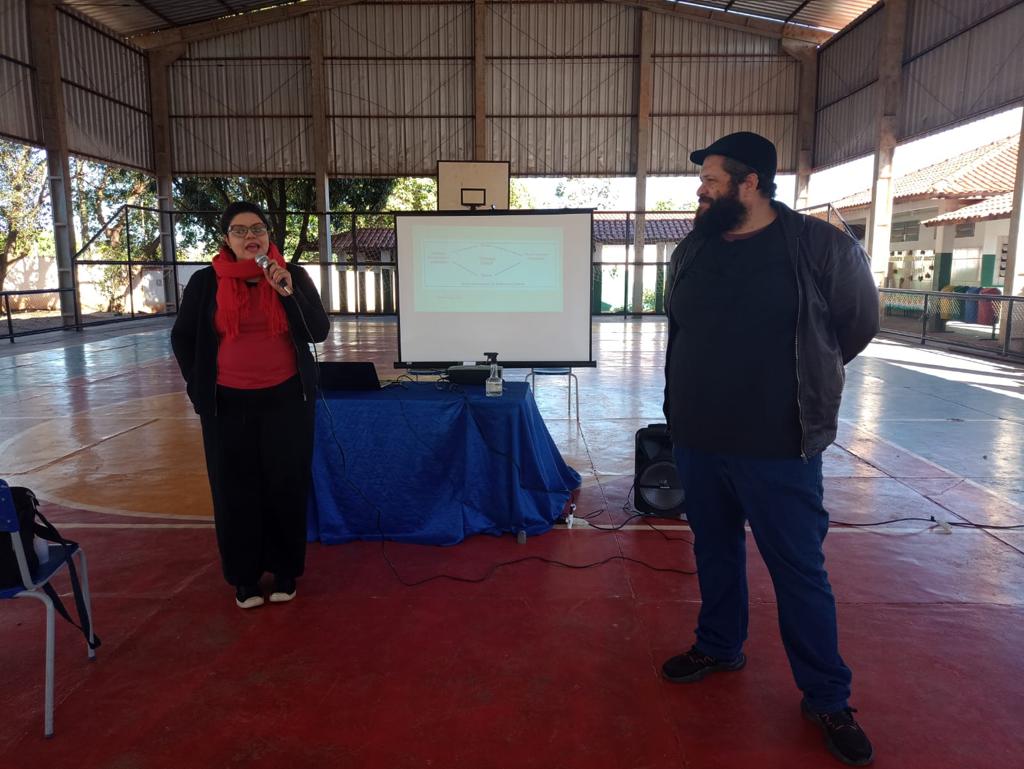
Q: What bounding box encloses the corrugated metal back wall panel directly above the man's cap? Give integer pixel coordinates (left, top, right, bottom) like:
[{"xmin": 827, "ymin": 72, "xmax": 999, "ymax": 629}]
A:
[{"xmin": 649, "ymin": 16, "xmax": 800, "ymax": 174}]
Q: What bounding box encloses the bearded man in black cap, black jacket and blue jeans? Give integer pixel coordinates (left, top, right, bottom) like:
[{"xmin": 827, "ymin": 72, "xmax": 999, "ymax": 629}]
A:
[{"xmin": 662, "ymin": 132, "xmax": 879, "ymax": 766}]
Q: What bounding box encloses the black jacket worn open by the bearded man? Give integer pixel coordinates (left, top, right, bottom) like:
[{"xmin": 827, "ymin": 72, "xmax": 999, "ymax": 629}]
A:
[{"xmin": 663, "ymin": 202, "xmax": 879, "ymax": 459}]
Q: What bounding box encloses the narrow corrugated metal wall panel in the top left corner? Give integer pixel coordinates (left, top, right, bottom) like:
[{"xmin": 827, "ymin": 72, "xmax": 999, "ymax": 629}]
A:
[{"xmin": 0, "ymin": 0, "xmax": 43, "ymax": 144}]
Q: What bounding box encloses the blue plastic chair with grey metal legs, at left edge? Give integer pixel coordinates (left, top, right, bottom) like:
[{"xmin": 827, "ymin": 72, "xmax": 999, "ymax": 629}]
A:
[{"xmin": 0, "ymin": 480, "xmax": 96, "ymax": 737}]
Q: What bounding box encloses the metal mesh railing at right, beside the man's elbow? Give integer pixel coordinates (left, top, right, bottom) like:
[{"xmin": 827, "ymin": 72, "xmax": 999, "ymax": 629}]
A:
[{"xmin": 879, "ymin": 289, "xmax": 1024, "ymax": 358}]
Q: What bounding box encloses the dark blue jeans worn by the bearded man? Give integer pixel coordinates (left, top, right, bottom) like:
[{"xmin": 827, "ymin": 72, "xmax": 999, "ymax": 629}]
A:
[{"xmin": 675, "ymin": 447, "xmax": 851, "ymax": 713}]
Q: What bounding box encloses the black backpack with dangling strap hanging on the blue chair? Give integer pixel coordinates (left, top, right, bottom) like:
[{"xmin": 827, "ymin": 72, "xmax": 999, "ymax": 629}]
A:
[{"xmin": 0, "ymin": 486, "xmax": 99, "ymax": 649}]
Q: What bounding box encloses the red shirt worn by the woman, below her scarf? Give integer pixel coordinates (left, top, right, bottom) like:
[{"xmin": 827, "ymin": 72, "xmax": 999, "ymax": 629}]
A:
[{"xmin": 217, "ymin": 284, "xmax": 299, "ymax": 390}]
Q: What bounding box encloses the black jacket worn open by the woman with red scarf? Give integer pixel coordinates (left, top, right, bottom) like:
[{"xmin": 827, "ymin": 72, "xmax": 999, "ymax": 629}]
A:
[{"xmin": 171, "ymin": 264, "xmax": 331, "ymax": 414}]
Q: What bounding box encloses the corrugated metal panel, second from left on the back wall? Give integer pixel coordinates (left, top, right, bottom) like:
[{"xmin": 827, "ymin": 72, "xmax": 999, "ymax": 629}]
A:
[{"xmin": 323, "ymin": 3, "xmax": 473, "ymax": 176}]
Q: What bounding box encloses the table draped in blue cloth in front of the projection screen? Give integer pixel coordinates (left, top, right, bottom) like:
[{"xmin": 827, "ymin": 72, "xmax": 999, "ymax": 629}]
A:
[{"xmin": 307, "ymin": 382, "xmax": 580, "ymax": 545}]
